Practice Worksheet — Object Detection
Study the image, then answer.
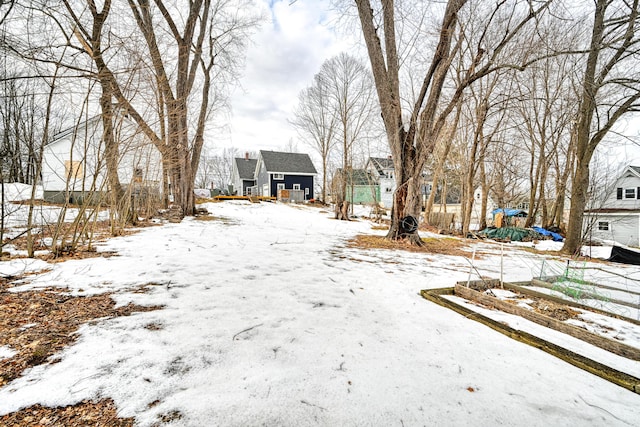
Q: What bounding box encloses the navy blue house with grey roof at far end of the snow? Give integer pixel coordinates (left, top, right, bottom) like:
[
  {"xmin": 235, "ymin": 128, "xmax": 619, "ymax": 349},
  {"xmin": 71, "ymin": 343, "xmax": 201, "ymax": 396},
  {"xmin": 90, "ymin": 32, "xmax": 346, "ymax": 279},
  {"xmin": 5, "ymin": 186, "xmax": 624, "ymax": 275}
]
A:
[{"xmin": 252, "ymin": 150, "xmax": 318, "ymax": 201}]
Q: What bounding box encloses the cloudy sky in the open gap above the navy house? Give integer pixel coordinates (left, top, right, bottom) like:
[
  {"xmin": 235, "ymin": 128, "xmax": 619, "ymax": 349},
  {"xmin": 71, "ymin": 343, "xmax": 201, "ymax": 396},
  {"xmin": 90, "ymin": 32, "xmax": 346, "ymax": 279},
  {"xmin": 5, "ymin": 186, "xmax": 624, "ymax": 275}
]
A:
[{"xmin": 222, "ymin": 0, "xmax": 355, "ymax": 153}]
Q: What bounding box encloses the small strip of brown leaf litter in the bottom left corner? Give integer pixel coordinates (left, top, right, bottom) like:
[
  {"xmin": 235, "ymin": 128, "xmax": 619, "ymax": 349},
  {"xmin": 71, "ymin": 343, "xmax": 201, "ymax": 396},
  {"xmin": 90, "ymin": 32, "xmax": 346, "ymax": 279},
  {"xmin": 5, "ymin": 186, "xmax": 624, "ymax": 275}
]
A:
[{"xmin": 0, "ymin": 399, "xmax": 134, "ymax": 427}]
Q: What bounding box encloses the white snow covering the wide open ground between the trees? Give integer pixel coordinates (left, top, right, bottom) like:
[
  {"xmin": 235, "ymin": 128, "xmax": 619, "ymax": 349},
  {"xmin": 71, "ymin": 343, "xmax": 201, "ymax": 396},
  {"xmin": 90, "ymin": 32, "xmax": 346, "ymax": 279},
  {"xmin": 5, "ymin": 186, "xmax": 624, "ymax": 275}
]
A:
[{"xmin": 0, "ymin": 201, "xmax": 640, "ymax": 426}]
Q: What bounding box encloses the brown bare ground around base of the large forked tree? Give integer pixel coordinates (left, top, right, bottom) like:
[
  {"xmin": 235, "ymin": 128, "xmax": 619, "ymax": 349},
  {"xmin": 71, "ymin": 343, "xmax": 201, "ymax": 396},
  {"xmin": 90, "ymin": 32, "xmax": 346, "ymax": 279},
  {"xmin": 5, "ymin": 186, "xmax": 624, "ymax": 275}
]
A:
[{"xmin": 347, "ymin": 234, "xmax": 469, "ymax": 257}]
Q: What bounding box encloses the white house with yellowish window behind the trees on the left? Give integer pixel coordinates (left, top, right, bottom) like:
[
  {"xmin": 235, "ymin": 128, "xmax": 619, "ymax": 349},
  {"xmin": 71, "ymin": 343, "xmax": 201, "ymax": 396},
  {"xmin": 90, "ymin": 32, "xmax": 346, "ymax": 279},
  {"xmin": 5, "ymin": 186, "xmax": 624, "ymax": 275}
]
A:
[{"xmin": 42, "ymin": 115, "xmax": 162, "ymax": 203}]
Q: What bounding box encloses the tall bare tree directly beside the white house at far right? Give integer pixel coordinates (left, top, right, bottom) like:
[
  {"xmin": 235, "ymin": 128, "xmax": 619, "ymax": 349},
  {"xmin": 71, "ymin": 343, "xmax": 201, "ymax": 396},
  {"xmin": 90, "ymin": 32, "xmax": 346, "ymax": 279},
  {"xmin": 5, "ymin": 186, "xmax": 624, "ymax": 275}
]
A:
[{"xmin": 562, "ymin": 0, "xmax": 640, "ymax": 254}]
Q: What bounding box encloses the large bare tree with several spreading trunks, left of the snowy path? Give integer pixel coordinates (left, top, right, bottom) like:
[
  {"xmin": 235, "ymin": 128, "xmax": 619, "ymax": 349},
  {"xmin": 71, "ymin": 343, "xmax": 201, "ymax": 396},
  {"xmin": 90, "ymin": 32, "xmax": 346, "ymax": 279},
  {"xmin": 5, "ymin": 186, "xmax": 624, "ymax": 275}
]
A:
[{"xmin": 50, "ymin": 0, "xmax": 258, "ymax": 215}]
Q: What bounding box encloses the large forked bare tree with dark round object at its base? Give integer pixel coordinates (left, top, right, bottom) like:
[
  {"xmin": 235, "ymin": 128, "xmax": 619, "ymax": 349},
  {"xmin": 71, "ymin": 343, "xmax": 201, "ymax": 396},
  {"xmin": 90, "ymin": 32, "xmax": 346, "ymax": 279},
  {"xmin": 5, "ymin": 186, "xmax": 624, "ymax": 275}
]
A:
[{"xmin": 355, "ymin": 0, "xmax": 550, "ymax": 245}]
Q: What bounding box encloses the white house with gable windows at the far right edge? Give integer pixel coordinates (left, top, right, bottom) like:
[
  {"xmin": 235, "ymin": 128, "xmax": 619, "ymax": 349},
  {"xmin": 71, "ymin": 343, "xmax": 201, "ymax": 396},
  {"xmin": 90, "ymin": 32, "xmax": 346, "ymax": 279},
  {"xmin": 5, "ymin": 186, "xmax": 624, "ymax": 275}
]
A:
[{"xmin": 583, "ymin": 166, "xmax": 640, "ymax": 246}]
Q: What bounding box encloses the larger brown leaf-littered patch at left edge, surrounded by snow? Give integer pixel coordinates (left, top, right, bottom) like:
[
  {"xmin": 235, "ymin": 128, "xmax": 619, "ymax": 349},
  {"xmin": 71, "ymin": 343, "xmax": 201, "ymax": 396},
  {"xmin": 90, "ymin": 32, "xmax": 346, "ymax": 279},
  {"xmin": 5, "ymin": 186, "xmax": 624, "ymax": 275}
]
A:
[{"xmin": 0, "ymin": 283, "xmax": 160, "ymax": 387}]
